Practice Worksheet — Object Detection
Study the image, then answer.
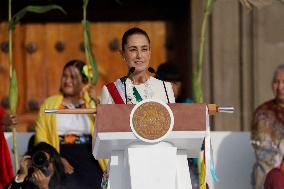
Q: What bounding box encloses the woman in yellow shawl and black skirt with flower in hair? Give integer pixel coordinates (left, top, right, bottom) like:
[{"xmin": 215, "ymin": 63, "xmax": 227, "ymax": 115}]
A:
[{"xmin": 35, "ymin": 60, "xmax": 102, "ymax": 189}]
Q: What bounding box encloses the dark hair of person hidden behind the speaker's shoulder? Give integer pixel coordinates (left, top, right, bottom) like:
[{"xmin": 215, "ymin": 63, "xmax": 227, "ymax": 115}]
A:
[{"xmin": 156, "ymin": 61, "xmax": 182, "ymax": 82}]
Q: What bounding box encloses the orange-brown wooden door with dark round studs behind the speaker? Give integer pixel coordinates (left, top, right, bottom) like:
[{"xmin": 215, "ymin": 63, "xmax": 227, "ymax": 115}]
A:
[{"xmin": 0, "ymin": 21, "xmax": 166, "ymax": 131}]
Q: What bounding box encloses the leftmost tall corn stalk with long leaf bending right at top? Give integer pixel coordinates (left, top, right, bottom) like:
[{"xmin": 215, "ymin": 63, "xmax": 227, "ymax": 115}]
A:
[{"xmin": 8, "ymin": 0, "xmax": 66, "ymax": 172}]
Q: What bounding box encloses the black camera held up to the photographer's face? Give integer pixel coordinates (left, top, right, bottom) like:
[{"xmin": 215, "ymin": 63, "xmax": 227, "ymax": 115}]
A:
[{"xmin": 32, "ymin": 151, "xmax": 50, "ymax": 176}]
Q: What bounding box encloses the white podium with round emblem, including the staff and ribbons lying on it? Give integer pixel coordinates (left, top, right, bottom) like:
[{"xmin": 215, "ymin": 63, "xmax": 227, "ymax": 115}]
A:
[{"xmin": 45, "ymin": 100, "xmax": 234, "ymax": 189}]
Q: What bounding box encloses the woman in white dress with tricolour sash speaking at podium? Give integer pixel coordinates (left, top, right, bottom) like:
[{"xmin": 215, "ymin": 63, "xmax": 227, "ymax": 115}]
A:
[{"xmin": 98, "ymin": 27, "xmax": 175, "ymax": 188}]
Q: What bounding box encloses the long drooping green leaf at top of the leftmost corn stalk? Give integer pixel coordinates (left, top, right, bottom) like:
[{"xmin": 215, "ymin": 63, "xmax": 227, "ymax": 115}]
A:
[{"xmin": 9, "ymin": 5, "xmax": 66, "ymax": 30}]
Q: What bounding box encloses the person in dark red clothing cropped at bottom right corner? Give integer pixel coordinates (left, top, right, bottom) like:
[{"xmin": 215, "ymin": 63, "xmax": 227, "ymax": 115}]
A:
[{"xmin": 264, "ymin": 156, "xmax": 284, "ymax": 189}]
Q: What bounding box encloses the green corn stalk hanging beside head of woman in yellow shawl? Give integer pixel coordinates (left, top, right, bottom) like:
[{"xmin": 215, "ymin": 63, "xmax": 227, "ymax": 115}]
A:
[{"xmin": 82, "ymin": 0, "xmax": 99, "ymax": 84}]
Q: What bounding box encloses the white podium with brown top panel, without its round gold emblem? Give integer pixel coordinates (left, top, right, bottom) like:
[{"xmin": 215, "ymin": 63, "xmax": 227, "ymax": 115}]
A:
[{"xmin": 93, "ymin": 103, "xmax": 208, "ymax": 189}]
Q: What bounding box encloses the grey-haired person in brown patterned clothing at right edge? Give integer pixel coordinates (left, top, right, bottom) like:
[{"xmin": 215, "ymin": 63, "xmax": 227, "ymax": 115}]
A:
[{"xmin": 251, "ymin": 64, "xmax": 284, "ymax": 189}]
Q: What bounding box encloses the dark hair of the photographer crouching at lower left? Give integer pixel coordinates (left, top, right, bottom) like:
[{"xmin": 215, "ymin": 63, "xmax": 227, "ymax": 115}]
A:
[{"xmin": 27, "ymin": 142, "xmax": 66, "ymax": 185}]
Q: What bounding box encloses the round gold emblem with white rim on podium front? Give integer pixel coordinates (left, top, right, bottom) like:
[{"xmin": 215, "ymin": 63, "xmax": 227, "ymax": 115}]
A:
[{"xmin": 130, "ymin": 100, "xmax": 173, "ymax": 142}]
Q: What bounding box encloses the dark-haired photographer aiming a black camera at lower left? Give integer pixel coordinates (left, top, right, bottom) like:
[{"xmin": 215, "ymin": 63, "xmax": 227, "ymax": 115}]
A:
[{"xmin": 6, "ymin": 142, "xmax": 71, "ymax": 189}]
